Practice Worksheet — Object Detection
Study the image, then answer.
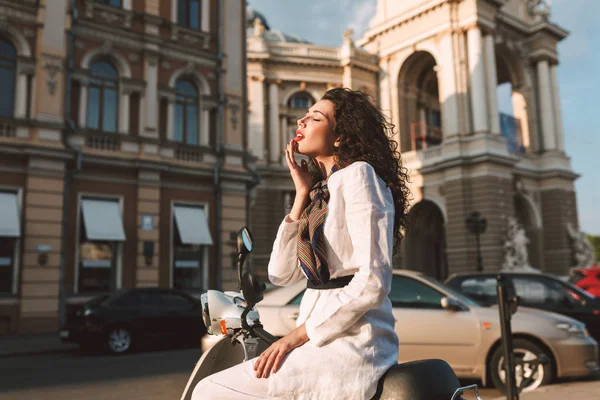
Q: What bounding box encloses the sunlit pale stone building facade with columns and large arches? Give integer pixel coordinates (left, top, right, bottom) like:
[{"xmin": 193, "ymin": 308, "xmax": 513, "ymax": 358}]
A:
[{"xmin": 247, "ymin": 0, "xmax": 578, "ymax": 279}]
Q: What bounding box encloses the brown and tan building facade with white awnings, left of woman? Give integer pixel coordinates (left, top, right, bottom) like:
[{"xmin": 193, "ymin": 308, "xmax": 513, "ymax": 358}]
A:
[{"xmin": 0, "ymin": 0, "xmax": 250, "ymax": 334}]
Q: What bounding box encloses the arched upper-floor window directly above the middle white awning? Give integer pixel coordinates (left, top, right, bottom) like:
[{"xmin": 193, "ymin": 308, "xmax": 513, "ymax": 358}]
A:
[{"xmin": 87, "ymin": 61, "xmax": 119, "ymax": 132}]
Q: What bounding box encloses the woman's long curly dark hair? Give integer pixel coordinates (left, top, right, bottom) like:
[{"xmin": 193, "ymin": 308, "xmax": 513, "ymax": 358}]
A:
[{"xmin": 321, "ymin": 88, "xmax": 410, "ymax": 253}]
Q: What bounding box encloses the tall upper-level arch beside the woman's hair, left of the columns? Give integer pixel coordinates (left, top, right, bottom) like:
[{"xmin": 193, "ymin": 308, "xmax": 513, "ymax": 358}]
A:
[{"xmin": 398, "ymin": 51, "xmax": 442, "ymax": 151}]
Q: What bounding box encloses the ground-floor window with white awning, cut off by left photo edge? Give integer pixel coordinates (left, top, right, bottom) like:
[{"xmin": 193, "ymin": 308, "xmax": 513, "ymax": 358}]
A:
[{"xmin": 0, "ymin": 191, "xmax": 21, "ymax": 294}]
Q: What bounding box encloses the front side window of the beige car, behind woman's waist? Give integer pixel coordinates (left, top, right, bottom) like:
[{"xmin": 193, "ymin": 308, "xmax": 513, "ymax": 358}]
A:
[{"xmin": 389, "ymin": 275, "xmax": 444, "ymax": 309}]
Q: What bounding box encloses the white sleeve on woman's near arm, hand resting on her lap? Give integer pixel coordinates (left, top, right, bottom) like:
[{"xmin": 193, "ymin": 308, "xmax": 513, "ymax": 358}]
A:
[{"xmin": 305, "ymin": 163, "xmax": 394, "ymax": 346}]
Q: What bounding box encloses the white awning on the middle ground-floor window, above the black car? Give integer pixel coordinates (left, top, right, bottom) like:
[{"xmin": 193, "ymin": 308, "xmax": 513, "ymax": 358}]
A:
[{"xmin": 82, "ymin": 199, "xmax": 125, "ymax": 242}]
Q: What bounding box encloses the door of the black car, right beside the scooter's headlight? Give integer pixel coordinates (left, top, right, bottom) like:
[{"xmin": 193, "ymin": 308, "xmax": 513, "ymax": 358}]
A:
[{"xmin": 160, "ymin": 291, "xmax": 203, "ymax": 338}]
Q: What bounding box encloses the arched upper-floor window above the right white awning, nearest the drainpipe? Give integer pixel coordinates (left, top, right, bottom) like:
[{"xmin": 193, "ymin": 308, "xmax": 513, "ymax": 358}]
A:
[{"xmin": 173, "ymin": 79, "xmax": 198, "ymax": 145}]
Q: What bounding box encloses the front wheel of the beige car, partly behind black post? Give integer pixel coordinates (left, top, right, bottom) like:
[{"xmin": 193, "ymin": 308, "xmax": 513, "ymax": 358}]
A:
[{"xmin": 488, "ymin": 339, "xmax": 554, "ymax": 393}]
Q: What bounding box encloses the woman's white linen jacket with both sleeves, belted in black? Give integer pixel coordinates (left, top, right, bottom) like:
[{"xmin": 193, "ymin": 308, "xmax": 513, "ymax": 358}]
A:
[{"xmin": 268, "ymin": 162, "xmax": 398, "ymax": 400}]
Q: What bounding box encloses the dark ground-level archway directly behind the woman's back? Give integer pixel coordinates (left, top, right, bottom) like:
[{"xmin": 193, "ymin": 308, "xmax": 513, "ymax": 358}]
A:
[{"xmin": 402, "ymin": 199, "xmax": 448, "ymax": 280}]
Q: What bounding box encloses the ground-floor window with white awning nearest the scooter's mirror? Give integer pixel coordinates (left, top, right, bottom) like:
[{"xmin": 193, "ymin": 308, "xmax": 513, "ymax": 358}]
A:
[{"xmin": 172, "ymin": 205, "xmax": 213, "ymax": 291}]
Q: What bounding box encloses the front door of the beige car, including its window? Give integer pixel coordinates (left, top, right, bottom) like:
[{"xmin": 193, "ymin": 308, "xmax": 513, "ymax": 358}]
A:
[{"xmin": 389, "ymin": 275, "xmax": 480, "ymax": 374}]
